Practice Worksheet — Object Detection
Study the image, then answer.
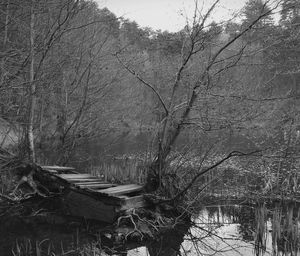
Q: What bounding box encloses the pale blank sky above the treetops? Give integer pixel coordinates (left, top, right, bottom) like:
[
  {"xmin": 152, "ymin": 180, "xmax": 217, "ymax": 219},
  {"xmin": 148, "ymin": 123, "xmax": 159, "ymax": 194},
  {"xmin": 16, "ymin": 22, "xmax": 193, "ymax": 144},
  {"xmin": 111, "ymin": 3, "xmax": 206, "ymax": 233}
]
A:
[{"xmin": 96, "ymin": 0, "xmax": 246, "ymax": 32}]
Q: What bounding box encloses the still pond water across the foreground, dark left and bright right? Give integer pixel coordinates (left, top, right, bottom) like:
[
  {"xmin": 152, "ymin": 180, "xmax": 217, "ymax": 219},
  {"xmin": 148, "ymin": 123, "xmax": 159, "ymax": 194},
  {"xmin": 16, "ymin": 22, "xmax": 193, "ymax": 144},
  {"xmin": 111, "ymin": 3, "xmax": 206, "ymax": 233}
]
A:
[{"xmin": 0, "ymin": 203, "xmax": 300, "ymax": 256}]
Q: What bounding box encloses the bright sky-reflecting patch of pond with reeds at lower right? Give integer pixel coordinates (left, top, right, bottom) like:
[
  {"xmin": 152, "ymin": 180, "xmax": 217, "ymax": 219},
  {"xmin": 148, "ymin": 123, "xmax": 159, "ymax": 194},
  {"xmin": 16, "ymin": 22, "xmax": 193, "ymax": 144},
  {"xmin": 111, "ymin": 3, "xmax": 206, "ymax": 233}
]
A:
[{"xmin": 185, "ymin": 204, "xmax": 300, "ymax": 256}]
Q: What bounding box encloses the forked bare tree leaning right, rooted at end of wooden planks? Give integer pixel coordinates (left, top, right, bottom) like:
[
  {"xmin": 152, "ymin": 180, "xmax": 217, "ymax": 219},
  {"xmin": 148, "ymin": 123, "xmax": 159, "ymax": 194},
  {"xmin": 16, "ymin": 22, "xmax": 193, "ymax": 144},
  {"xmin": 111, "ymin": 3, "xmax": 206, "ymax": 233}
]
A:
[{"xmin": 116, "ymin": 0, "xmax": 279, "ymax": 191}]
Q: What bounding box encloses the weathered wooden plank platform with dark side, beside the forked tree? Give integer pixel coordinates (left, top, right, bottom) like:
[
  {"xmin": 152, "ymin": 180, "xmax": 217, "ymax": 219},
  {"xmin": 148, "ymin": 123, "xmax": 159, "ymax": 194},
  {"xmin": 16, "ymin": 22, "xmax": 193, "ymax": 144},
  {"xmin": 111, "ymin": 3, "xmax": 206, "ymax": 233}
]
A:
[{"xmin": 38, "ymin": 166, "xmax": 146, "ymax": 223}]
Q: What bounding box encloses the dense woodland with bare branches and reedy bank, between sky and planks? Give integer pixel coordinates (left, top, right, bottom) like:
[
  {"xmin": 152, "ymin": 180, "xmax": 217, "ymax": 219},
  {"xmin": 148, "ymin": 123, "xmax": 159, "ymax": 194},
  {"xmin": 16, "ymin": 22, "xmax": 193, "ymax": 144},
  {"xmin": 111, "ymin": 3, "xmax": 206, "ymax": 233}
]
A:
[{"xmin": 0, "ymin": 0, "xmax": 300, "ymax": 200}]
